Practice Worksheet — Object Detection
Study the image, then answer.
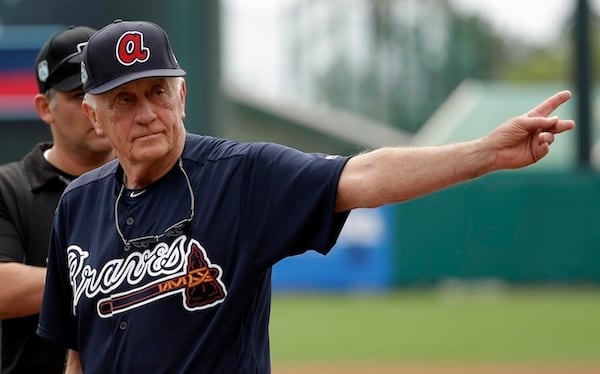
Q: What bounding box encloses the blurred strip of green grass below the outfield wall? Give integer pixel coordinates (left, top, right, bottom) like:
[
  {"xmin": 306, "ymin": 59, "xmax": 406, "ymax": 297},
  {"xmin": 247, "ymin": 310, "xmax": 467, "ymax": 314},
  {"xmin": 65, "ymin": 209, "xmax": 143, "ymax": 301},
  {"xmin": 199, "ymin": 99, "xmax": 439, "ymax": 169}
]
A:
[{"xmin": 270, "ymin": 289, "xmax": 600, "ymax": 363}]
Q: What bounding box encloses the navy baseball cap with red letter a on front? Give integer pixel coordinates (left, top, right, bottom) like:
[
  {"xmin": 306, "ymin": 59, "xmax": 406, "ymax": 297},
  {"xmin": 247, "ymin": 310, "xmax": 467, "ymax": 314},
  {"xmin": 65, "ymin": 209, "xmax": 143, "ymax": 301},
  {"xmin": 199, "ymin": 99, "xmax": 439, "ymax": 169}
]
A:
[{"xmin": 81, "ymin": 20, "xmax": 185, "ymax": 94}]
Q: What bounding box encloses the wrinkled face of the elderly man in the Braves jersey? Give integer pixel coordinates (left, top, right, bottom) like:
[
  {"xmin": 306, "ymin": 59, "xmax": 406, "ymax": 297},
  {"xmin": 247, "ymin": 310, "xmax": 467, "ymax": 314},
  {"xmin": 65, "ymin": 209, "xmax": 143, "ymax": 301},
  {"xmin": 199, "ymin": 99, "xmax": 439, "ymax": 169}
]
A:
[{"xmin": 83, "ymin": 77, "xmax": 185, "ymax": 164}]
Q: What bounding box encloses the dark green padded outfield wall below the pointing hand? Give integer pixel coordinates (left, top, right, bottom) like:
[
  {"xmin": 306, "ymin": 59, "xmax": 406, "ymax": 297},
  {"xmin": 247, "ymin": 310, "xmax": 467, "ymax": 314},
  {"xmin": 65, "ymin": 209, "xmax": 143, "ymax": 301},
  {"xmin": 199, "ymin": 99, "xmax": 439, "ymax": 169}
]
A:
[{"xmin": 395, "ymin": 172, "xmax": 600, "ymax": 285}]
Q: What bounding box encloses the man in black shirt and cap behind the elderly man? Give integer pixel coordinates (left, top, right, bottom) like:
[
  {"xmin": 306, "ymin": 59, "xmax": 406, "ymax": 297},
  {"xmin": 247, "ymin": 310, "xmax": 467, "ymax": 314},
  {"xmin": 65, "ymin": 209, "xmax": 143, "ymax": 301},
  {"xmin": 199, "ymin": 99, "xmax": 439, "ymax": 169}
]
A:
[{"xmin": 0, "ymin": 26, "xmax": 114, "ymax": 374}]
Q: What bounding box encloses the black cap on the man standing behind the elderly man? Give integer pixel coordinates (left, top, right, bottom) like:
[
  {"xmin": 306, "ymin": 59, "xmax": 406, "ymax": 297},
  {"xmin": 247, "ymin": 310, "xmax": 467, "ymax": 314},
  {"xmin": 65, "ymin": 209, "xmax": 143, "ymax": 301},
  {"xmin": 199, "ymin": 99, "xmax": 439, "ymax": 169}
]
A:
[{"xmin": 35, "ymin": 26, "xmax": 96, "ymax": 93}]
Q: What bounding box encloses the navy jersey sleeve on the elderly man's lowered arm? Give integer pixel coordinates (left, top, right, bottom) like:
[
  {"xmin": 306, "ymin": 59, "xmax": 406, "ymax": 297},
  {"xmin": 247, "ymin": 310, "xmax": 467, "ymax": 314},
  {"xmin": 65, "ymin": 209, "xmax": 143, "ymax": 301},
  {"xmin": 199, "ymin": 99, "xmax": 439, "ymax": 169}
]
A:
[{"xmin": 37, "ymin": 202, "xmax": 78, "ymax": 350}]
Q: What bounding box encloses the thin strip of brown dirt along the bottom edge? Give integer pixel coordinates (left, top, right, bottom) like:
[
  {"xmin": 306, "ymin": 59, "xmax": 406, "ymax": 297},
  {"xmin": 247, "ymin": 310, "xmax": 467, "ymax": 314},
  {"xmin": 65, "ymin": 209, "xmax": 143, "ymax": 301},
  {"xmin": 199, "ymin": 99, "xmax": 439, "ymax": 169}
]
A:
[{"xmin": 272, "ymin": 363, "xmax": 600, "ymax": 374}]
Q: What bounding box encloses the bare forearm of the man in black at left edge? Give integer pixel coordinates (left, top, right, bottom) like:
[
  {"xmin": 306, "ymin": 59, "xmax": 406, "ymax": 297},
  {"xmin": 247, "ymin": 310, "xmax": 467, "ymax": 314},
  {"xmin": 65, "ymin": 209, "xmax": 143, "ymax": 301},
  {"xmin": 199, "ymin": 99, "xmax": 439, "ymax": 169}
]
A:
[{"xmin": 0, "ymin": 262, "xmax": 46, "ymax": 319}]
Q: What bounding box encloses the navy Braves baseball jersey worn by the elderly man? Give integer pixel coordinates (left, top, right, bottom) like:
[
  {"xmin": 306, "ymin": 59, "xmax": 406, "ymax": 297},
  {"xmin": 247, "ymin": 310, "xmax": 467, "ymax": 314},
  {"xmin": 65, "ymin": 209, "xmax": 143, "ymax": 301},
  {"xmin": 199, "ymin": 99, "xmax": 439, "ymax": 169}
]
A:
[{"xmin": 38, "ymin": 134, "xmax": 348, "ymax": 373}]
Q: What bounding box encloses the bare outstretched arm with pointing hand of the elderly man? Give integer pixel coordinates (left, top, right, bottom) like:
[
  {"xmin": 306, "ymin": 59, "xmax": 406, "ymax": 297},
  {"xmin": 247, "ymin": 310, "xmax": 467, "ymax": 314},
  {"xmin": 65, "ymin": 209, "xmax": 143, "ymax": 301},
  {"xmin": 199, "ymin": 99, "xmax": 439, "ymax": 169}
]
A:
[{"xmin": 336, "ymin": 91, "xmax": 575, "ymax": 211}]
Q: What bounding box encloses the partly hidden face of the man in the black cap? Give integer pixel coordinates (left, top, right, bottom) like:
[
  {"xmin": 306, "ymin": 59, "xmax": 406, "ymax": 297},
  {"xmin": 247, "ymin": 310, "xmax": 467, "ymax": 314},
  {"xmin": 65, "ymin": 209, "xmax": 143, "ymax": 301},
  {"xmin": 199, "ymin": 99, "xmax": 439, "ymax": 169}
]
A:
[{"xmin": 41, "ymin": 89, "xmax": 112, "ymax": 155}]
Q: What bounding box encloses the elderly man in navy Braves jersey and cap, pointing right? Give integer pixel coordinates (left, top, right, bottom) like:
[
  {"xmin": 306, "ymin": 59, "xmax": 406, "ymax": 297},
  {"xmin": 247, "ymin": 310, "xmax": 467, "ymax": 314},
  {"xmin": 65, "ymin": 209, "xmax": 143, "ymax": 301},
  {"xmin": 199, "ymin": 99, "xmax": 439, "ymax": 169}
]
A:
[{"xmin": 38, "ymin": 21, "xmax": 574, "ymax": 373}]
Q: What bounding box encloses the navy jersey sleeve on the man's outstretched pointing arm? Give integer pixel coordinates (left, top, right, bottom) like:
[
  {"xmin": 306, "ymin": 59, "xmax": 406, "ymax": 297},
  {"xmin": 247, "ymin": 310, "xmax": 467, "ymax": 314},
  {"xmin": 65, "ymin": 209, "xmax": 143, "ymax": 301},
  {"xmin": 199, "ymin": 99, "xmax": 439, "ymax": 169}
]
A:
[{"xmin": 242, "ymin": 143, "xmax": 348, "ymax": 263}]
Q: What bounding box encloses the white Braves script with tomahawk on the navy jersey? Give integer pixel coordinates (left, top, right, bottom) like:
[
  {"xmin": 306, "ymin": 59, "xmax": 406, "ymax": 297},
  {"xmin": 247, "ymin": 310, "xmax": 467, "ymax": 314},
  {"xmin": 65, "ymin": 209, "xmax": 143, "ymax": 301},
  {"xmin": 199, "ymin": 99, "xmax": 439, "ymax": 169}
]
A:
[{"xmin": 67, "ymin": 235, "xmax": 227, "ymax": 318}]
